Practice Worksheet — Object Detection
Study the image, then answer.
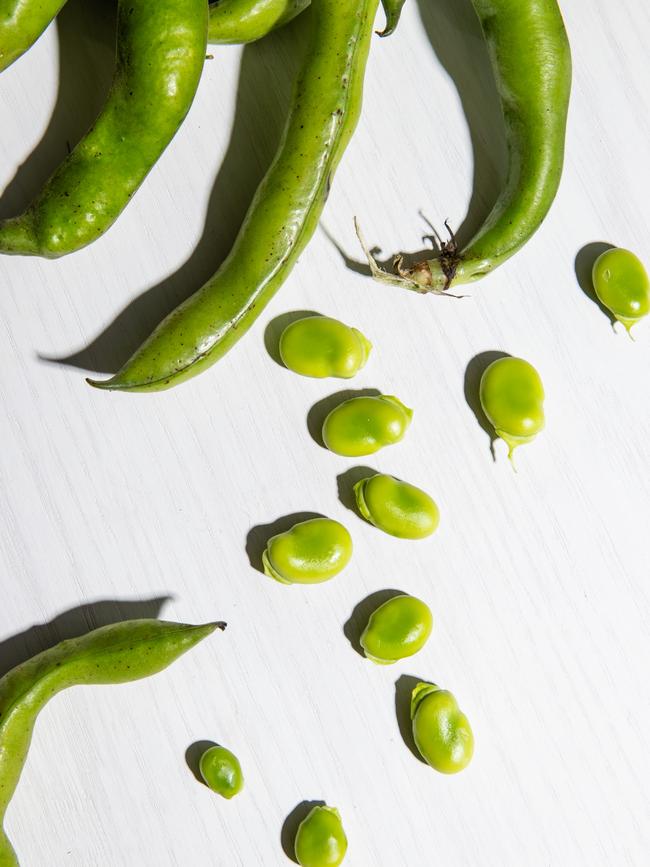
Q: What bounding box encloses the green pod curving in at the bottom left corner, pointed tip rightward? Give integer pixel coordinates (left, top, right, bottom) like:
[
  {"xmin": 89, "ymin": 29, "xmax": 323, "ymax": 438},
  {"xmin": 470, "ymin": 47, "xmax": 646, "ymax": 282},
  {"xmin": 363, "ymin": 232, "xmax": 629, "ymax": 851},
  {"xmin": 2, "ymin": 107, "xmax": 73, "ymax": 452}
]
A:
[{"xmin": 0, "ymin": 620, "xmax": 225, "ymax": 867}]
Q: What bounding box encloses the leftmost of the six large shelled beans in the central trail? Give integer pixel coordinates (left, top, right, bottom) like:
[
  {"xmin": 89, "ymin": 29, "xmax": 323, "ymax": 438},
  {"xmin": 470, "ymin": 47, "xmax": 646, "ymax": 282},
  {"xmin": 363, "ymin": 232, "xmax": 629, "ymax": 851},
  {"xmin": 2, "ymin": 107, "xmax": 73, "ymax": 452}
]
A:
[{"xmin": 262, "ymin": 518, "xmax": 352, "ymax": 584}]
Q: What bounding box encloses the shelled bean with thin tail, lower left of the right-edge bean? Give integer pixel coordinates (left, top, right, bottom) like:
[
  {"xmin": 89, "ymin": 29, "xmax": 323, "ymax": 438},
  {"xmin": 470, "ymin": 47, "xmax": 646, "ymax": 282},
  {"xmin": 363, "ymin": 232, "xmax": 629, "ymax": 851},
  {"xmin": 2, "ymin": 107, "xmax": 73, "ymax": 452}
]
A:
[{"xmin": 479, "ymin": 356, "xmax": 544, "ymax": 459}]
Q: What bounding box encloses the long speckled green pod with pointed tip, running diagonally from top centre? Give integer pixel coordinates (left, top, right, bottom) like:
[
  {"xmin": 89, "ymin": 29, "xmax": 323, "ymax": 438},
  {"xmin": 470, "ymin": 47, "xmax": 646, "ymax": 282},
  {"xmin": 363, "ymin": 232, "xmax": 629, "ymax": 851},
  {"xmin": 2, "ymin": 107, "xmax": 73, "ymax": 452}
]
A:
[{"xmin": 90, "ymin": 0, "xmax": 378, "ymax": 391}]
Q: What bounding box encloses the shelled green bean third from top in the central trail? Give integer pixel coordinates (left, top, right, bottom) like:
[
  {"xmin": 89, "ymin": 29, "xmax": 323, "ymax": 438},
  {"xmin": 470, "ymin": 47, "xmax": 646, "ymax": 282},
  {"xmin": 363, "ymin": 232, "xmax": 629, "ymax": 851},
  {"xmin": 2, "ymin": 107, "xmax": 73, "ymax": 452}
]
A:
[{"xmin": 354, "ymin": 473, "xmax": 440, "ymax": 539}]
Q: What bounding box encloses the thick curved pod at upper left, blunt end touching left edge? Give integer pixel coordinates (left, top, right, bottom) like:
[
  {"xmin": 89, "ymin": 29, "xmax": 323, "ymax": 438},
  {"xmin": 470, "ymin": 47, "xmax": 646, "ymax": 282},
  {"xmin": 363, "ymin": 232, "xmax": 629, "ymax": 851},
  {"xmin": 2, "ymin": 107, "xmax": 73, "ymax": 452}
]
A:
[{"xmin": 0, "ymin": 0, "xmax": 207, "ymax": 258}]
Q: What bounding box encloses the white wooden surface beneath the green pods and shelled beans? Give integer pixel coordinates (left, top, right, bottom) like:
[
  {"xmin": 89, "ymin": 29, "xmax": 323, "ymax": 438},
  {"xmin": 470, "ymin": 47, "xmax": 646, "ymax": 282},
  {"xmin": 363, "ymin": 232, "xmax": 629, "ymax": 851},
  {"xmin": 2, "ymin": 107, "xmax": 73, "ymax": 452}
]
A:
[{"xmin": 0, "ymin": 0, "xmax": 650, "ymax": 867}]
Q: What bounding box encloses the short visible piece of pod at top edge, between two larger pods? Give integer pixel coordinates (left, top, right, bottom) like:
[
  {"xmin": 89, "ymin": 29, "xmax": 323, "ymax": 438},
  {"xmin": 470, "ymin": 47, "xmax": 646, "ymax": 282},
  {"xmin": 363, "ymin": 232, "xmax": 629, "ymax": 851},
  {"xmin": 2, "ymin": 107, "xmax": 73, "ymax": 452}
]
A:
[{"xmin": 208, "ymin": 0, "xmax": 311, "ymax": 45}]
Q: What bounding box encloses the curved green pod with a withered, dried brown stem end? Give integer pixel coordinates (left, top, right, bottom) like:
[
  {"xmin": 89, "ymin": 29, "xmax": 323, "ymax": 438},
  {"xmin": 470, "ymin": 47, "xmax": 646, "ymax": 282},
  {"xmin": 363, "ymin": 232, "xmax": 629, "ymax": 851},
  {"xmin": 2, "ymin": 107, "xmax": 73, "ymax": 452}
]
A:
[{"xmin": 362, "ymin": 0, "xmax": 571, "ymax": 293}]
